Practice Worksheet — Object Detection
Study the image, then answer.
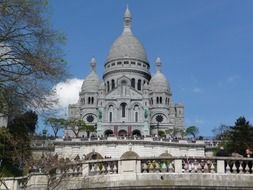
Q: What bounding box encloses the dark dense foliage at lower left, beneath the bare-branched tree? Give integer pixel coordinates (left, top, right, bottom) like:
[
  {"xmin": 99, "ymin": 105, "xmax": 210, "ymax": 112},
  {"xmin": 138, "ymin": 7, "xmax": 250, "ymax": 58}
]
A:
[{"xmin": 0, "ymin": 111, "xmax": 37, "ymax": 176}]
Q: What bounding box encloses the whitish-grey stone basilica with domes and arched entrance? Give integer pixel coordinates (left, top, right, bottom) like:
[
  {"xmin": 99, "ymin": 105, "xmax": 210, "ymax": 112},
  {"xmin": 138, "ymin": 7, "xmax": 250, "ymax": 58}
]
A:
[{"xmin": 65, "ymin": 8, "xmax": 184, "ymax": 136}]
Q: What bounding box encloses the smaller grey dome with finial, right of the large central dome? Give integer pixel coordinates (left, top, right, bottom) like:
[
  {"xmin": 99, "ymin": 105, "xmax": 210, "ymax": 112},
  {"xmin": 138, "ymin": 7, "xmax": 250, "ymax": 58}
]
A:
[{"xmin": 149, "ymin": 57, "xmax": 170, "ymax": 92}]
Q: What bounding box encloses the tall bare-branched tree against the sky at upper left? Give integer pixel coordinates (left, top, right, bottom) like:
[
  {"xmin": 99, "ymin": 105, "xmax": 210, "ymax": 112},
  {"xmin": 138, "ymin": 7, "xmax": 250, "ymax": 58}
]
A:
[{"xmin": 0, "ymin": 0, "xmax": 65, "ymax": 114}]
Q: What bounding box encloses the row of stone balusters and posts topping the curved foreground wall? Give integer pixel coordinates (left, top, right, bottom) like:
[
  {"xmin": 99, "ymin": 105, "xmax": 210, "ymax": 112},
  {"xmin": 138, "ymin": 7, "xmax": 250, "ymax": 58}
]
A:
[{"xmin": 48, "ymin": 157, "xmax": 253, "ymax": 177}]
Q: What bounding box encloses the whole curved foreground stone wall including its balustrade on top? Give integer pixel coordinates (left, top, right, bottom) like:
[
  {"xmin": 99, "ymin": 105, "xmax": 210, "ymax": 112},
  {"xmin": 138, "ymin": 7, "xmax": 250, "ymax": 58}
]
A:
[{"xmin": 0, "ymin": 157, "xmax": 253, "ymax": 190}]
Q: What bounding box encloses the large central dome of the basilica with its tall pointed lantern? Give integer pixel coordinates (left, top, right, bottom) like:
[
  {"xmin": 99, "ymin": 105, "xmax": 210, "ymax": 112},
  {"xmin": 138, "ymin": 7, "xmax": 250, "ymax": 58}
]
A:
[{"xmin": 107, "ymin": 8, "xmax": 148, "ymax": 62}]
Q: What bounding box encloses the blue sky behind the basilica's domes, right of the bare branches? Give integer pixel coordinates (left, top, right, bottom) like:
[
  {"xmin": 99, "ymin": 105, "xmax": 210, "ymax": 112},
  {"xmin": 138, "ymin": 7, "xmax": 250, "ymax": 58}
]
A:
[{"xmin": 49, "ymin": 0, "xmax": 253, "ymax": 136}]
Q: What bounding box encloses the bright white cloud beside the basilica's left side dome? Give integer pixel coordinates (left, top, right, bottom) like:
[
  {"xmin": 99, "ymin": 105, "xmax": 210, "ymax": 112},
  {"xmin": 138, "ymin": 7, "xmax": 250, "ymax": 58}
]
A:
[{"xmin": 53, "ymin": 78, "xmax": 83, "ymax": 109}]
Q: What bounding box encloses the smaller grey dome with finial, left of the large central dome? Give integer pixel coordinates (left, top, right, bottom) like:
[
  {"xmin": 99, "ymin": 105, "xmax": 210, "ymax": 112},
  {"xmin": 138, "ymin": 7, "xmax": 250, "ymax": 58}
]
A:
[{"xmin": 82, "ymin": 58, "xmax": 100, "ymax": 92}]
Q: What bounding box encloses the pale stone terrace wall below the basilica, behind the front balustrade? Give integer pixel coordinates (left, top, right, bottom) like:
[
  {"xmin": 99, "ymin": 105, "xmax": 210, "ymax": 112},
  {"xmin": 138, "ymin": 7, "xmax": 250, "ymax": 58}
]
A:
[{"xmin": 55, "ymin": 139, "xmax": 205, "ymax": 159}]
